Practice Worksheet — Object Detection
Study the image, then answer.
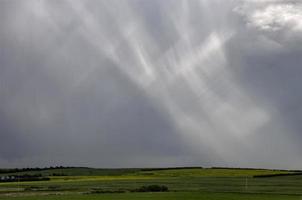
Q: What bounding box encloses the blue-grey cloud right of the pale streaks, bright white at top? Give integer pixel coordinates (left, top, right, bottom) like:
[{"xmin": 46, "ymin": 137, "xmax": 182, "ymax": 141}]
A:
[{"xmin": 227, "ymin": 1, "xmax": 302, "ymax": 168}]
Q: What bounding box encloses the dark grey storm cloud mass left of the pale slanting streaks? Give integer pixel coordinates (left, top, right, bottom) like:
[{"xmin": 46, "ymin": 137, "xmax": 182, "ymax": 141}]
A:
[{"xmin": 1, "ymin": 2, "xmax": 189, "ymax": 166}]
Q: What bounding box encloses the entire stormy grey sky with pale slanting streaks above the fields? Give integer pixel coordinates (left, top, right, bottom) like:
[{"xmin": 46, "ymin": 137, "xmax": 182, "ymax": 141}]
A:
[{"xmin": 0, "ymin": 0, "xmax": 302, "ymax": 169}]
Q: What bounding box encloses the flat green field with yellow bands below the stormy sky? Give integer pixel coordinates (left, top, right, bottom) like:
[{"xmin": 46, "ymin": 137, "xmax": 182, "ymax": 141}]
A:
[{"xmin": 0, "ymin": 168, "xmax": 302, "ymax": 200}]
